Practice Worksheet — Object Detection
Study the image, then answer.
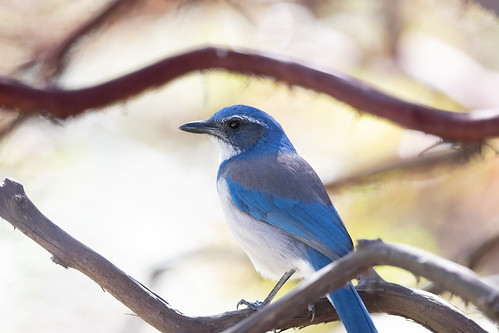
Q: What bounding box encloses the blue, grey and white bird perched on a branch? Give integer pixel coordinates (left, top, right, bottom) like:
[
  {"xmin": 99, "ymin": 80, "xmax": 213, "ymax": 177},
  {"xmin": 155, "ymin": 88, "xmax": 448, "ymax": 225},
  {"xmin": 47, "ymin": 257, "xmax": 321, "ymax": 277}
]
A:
[{"xmin": 180, "ymin": 105, "xmax": 377, "ymax": 333}]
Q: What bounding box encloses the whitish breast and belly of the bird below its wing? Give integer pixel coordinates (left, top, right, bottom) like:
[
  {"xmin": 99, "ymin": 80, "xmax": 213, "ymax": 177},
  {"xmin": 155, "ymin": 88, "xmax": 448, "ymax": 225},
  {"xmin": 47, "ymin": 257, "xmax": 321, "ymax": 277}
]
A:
[{"xmin": 217, "ymin": 178, "xmax": 314, "ymax": 279}]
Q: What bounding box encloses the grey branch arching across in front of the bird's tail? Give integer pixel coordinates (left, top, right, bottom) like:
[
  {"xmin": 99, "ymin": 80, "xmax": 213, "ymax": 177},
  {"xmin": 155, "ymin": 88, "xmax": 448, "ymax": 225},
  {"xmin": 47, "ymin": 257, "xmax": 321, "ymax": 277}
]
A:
[{"xmin": 226, "ymin": 241, "xmax": 499, "ymax": 333}]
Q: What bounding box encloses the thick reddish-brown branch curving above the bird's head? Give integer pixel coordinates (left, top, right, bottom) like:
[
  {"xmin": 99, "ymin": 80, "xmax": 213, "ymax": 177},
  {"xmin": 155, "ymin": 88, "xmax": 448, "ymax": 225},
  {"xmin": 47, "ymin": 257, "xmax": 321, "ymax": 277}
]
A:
[{"xmin": 0, "ymin": 47, "xmax": 499, "ymax": 141}]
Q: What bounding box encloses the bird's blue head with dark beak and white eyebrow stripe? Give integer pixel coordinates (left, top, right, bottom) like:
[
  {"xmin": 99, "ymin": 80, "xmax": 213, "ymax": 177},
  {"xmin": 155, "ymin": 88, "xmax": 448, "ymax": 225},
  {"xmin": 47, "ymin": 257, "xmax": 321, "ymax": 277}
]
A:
[{"xmin": 179, "ymin": 105, "xmax": 294, "ymax": 160}]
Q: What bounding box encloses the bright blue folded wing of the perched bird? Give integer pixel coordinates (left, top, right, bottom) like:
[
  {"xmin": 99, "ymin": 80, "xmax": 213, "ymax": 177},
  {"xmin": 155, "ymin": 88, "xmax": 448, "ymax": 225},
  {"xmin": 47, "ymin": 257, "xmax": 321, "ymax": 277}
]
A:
[{"xmin": 226, "ymin": 178, "xmax": 353, "ymax": 260}]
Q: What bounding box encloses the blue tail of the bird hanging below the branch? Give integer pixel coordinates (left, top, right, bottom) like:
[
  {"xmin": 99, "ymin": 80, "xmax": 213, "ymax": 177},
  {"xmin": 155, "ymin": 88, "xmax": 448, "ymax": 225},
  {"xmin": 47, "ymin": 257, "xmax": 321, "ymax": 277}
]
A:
[{"xmin": 327, "ymin": 283, "xmax": 378, "ymax": 333}]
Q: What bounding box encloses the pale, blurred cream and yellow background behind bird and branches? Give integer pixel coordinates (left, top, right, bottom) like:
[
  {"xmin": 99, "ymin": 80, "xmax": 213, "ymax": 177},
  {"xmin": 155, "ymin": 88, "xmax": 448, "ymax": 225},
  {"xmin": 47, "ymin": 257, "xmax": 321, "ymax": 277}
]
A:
[{"xmin": 0, "ymin": 0, "xmax": 499, "ymax": 333}]
